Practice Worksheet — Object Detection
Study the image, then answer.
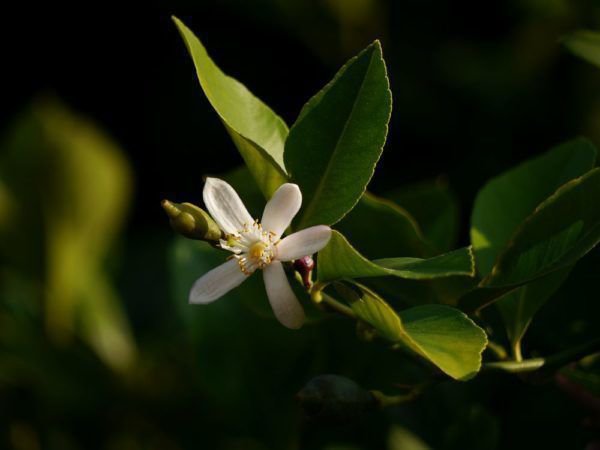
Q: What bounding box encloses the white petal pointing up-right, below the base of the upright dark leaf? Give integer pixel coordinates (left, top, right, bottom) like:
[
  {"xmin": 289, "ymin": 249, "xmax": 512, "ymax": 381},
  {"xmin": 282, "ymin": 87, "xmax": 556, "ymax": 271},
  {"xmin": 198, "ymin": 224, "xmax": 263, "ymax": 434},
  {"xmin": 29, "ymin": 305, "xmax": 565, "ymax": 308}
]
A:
[{"xmin": 261, "ymin": 183, "xmax": 302, "ymax": 238}]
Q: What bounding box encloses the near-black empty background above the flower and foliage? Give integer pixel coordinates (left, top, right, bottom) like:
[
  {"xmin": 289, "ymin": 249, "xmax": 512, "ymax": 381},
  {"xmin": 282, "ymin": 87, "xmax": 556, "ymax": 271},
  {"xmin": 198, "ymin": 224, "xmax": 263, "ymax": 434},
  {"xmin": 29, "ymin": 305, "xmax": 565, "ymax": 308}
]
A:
[{"xmin": 0, "ymin": 0, "xmax": 600, "ymax": 232}]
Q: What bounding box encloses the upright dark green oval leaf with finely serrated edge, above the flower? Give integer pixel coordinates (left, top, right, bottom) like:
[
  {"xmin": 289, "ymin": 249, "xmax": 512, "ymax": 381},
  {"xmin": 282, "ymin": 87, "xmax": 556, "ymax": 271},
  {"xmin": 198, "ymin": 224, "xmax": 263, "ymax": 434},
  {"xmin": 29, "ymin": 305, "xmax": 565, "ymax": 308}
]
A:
[{"xmin": 285, "ymin": 41, "xmax": 392, "ymax": 228}]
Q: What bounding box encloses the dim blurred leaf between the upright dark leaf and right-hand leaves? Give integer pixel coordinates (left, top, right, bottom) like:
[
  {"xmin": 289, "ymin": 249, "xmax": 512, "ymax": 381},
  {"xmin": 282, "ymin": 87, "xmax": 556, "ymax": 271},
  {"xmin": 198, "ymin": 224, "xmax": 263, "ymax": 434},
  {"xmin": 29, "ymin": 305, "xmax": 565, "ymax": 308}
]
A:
[{"xmin": 384, "ymin": 181, "xmax": 459, "ymax": 255}]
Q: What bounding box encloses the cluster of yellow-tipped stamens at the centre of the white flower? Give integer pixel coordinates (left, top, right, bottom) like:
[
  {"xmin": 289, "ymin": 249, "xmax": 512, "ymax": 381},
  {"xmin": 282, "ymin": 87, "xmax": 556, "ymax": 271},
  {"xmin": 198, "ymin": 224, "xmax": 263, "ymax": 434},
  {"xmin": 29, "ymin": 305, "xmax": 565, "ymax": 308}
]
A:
[{"xmin": 220, "ymin": 220, "xmax": 277, "ymax": 275}]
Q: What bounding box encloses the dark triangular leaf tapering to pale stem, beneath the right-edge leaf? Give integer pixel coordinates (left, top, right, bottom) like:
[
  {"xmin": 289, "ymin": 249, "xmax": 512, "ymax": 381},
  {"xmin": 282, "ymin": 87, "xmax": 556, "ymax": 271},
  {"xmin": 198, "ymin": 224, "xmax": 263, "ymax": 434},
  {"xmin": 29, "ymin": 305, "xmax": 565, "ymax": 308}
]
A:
[{"xmin": 496, "ymin": 267, "xmax": 572, "ymax": 346}]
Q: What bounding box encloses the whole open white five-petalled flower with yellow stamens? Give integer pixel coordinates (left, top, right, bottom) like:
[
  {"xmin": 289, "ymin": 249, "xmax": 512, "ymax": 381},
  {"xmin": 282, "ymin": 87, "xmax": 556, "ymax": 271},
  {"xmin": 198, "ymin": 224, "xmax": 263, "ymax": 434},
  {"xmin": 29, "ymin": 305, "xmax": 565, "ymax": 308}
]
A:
[{"xmin": 190, "ymin": 178, "xmax": 331, "ymax": 328}]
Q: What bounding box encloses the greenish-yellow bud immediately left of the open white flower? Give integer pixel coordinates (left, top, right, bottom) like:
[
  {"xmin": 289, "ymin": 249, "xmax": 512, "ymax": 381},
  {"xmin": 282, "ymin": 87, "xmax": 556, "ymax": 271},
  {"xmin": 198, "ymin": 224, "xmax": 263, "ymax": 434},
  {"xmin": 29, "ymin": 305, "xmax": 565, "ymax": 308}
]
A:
[{"xmin": 161, "ymin": 200, "xmax": 221, "ymax": 241}]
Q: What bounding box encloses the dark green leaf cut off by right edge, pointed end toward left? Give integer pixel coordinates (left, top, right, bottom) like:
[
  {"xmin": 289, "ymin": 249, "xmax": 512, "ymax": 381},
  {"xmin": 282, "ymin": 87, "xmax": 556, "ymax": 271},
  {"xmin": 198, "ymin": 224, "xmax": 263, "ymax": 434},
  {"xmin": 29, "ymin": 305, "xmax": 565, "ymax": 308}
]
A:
[{"xmin": 481, "ymin": 169, "xmax": 600, "ymax": 287}]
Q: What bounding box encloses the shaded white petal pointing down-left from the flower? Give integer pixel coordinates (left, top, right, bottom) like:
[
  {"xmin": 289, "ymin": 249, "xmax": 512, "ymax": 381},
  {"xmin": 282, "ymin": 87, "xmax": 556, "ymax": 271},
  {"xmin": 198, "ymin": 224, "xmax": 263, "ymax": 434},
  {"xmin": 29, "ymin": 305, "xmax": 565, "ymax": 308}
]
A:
[{"xmin": 189, "ymin": 258, "xmax": 247, "ymax": 304}]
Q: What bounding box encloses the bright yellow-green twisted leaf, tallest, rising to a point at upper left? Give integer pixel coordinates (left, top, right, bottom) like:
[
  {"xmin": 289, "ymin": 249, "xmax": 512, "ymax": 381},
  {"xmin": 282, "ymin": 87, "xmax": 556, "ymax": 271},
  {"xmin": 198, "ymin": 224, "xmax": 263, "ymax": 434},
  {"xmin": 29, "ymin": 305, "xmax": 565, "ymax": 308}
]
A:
[{"xmin": 173, "ymin": 17, "xmax": 288, "ymax": 198}]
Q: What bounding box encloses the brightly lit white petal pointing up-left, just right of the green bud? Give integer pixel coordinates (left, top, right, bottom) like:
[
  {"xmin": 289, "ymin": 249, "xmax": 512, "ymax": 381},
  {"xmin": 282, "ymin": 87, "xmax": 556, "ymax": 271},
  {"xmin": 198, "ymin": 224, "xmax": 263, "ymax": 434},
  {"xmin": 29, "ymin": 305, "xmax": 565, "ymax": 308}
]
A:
[{"xmin": 203, "ymin": 178, "xmax": 254, "ymax": 234}]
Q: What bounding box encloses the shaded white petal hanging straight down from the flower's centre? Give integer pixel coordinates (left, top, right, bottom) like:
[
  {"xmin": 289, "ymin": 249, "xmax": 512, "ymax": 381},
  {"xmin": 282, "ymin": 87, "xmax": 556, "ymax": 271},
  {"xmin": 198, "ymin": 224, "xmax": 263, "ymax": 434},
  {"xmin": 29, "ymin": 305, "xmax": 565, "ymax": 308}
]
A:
[{"xmin": 263, "ymin": 261, "xmax": 304, "ymax": 329}]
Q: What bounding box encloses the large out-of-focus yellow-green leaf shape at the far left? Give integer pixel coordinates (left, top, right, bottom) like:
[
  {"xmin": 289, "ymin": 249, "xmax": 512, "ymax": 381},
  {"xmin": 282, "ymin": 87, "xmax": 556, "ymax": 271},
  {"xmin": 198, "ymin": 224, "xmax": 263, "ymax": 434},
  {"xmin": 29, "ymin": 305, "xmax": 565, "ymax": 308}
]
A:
[{"xmin": 0, "ymin": 101, "xmax": 135, "ymax": 369}]
